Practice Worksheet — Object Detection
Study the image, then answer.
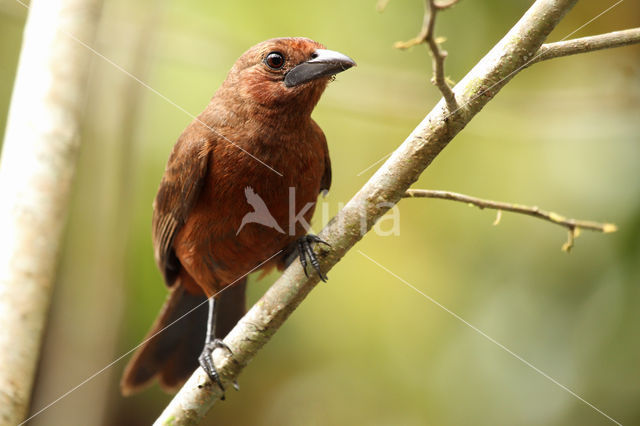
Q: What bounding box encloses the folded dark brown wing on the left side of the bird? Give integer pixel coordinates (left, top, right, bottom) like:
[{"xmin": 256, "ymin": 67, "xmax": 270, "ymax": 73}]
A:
[{"xmin": 152, "ymin": 134, "xmax": 210, "ymax": 286}]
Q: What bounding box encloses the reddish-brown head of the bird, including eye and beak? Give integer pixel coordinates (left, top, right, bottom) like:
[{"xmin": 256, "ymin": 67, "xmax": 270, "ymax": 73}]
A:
[{"xmin": 223, "ymin": 37, "xmax": 356, "ymax": 114}]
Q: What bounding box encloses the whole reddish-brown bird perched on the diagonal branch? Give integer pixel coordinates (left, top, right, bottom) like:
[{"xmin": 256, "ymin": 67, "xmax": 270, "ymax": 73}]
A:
[{"xmin": 121, "ymin": 38, "xmax": 355, "ymax": 394}]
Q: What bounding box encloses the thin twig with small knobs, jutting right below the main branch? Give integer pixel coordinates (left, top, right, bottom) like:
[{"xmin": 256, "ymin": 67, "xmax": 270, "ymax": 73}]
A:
[{"xmin": 403, "ymin": 189, "xmax": 618, "ymax": 251}]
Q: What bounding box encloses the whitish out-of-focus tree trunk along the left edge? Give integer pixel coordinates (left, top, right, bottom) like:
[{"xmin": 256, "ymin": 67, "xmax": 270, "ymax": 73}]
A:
[{"xmin": 0, "ymin": 0, "xmax": 101, "ymax": 424}]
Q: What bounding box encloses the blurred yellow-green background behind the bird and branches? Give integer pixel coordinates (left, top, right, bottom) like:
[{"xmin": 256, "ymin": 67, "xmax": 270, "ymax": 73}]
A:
[{"xmin": 0, "ymin": 0, "xmax": 640, "ymax": 425}]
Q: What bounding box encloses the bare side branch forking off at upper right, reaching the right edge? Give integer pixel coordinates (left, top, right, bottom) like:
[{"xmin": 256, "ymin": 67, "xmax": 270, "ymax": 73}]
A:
[{"xmin": 531, "ymin": 28, "xmax": 640, "ymax": 64}]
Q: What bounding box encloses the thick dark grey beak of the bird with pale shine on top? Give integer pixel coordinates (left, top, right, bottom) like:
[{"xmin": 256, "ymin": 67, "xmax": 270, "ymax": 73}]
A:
[{"xmin": 284, "ymin": 49, "xmax": 356, "ymax": 87}]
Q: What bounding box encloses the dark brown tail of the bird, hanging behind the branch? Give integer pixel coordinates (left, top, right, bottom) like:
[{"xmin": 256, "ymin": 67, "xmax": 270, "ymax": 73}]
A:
[{"xmin": 120, "ymin": 280, "xmax": 246, "ymax": 395}]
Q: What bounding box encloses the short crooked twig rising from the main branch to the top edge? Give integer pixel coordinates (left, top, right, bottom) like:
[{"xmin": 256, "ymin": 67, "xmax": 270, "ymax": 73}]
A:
[{"xmin": 394, "ymin": 0, "xmax": 459, "ymax": 114}]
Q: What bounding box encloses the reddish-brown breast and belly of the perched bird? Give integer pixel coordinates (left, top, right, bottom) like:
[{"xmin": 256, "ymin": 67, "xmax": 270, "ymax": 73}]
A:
[{"xmin": 176, "ymin": 128, "xmax": 325, "ymax": 287}]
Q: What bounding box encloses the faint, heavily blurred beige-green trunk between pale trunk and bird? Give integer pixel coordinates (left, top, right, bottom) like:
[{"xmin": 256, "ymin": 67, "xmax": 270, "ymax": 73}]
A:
[{"xmin": 29, "ymin": 1, "xmax": 163, "ymax": 426}]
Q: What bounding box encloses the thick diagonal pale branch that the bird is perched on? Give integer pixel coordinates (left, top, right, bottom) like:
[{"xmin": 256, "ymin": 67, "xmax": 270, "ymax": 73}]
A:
[{"xmin": 155, "ymin": 0, "xmax": 577, "ymax": 425}]
